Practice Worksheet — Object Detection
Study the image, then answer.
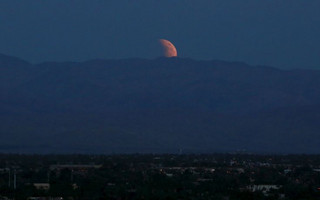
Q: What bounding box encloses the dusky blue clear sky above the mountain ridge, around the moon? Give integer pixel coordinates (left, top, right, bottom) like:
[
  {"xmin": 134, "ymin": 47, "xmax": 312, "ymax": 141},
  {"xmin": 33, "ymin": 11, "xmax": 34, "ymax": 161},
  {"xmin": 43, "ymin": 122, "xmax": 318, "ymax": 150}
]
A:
[{"xmin": 0, "ymin": 0, "xmax": 320, "ymax": 69}]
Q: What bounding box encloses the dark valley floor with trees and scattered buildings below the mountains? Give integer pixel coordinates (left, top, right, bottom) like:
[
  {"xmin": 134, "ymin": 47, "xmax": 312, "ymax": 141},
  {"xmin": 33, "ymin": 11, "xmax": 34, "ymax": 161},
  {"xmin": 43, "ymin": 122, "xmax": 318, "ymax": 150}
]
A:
[{"xmin": 0, "ymin": 154, "xmax": 320, "ymax": 200}]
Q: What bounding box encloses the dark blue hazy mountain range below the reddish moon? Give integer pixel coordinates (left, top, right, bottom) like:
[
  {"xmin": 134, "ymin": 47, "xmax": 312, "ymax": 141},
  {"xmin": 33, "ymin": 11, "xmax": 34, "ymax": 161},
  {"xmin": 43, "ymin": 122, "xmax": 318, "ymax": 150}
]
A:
[{"xmin": 0, "ymin": 55, "xmax": 320, "ymax": 153}]
